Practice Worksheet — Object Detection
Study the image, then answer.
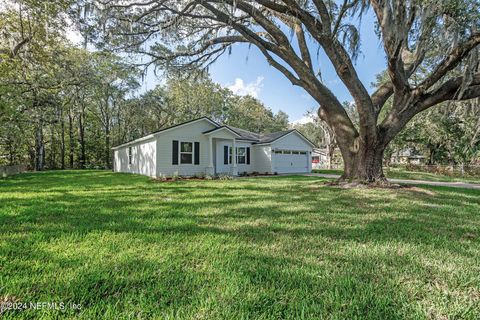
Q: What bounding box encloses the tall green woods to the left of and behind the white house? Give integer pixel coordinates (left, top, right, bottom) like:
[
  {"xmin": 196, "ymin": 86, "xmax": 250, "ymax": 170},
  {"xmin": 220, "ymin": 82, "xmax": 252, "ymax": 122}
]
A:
[{"xmin": 0, "ymin": 1, "xmax": 288, "ymax": 170}]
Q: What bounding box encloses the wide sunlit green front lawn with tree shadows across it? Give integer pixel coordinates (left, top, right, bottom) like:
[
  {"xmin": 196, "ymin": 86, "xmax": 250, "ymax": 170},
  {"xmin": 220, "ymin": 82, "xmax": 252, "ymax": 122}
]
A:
[{"xmin": 0, "ymin": 171, "xmax": 480, "ymax": 319}]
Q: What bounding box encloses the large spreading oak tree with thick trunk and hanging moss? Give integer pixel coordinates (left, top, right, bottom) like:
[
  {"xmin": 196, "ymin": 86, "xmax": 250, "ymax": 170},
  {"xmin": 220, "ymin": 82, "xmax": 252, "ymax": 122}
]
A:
[{"xmin": 86, "ymin": 0, "xmax": 480, "ymax": 182}]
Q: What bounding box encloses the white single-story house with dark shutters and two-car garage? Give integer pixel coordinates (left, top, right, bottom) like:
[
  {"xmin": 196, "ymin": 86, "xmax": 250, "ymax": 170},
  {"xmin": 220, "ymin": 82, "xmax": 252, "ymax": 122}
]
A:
[{"xmin": 112, "ymin": 117, "xmax": 314, "ymax": 177}]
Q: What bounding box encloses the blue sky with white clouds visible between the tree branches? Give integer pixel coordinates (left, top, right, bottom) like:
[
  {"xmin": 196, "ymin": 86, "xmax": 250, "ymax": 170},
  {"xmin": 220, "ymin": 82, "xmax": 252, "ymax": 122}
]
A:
[{"xmin": 69, "ymin": 11, "xmax": 386, "ymax": 123}]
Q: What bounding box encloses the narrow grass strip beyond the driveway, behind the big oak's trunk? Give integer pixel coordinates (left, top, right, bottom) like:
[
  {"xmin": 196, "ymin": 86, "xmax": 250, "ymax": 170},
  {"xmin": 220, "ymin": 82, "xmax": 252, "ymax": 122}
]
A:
[{"xmin": 313, "ymin": 168, "xmax": 480, "ymax": 183}]
